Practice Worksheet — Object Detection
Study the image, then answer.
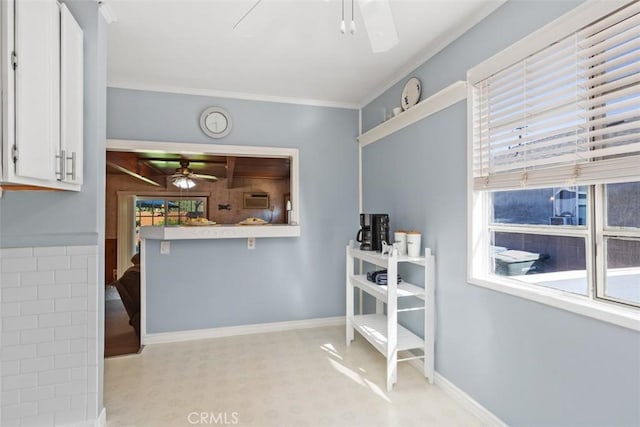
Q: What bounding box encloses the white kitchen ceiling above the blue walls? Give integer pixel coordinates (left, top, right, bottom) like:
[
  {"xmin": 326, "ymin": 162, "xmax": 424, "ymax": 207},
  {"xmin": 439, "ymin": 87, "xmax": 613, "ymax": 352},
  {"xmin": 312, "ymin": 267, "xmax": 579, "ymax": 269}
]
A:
[{"xmin": 107, "ymin": 0, "xmax": 506, "ymax": 108}]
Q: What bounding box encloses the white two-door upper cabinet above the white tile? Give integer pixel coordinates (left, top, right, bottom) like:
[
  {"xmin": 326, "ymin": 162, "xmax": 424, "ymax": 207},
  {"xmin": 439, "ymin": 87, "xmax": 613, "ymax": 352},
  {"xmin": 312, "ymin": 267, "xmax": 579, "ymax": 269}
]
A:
[{"xmin": 0, "ymin": 0, "xmax": 84, "ymax": 191}]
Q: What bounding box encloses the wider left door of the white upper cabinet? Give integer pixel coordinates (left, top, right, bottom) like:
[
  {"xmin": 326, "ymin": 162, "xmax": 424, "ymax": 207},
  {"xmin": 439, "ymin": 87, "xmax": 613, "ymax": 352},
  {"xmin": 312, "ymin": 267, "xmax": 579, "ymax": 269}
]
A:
[{"xmin": 15, "ymin": 0, "xmax": 60, "ymax": 181}]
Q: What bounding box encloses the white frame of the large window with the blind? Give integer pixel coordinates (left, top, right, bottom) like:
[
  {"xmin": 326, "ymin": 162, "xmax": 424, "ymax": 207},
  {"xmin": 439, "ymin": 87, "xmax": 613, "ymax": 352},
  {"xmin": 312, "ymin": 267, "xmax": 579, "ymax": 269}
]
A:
[{"xmin": 467, "ymin": 1, "xmax": 640, "ymax": 331}]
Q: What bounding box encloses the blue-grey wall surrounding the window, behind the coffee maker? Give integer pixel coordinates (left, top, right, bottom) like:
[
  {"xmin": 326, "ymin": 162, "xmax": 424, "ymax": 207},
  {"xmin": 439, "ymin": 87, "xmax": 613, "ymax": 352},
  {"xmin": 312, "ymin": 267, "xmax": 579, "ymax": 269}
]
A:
[{"xmin": 363, "ymin": 1, "xmax": 640, "ymax": 426}]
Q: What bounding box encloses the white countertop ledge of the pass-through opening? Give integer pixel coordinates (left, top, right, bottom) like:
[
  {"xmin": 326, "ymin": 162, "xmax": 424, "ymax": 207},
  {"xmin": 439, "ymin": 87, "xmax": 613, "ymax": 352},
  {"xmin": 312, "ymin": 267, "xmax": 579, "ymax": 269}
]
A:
[{"xmin": 140, "ymin": 224, "xmax": 300, "ymax": 240}]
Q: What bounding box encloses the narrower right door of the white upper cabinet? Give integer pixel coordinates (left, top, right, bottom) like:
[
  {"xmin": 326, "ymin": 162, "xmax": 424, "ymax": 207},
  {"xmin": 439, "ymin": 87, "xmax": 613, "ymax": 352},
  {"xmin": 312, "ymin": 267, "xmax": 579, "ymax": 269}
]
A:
[{"xmin": 60, "ymin": 4, "xmax": 84, "ymax": 184}]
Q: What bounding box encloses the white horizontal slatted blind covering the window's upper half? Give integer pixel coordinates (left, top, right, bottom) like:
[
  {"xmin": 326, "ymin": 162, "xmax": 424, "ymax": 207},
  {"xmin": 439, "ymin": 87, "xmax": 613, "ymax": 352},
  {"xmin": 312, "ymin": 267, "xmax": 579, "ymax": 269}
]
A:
[{"xmin": 472, "ymin": 1, "xmax": 640, "ymax": 190}]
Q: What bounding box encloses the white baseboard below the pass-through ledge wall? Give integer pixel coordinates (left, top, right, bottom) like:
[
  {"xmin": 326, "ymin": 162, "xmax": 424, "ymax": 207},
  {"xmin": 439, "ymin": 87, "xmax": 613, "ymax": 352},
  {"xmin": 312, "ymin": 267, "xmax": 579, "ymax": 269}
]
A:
[{"xmin": 142, "ymin": 316, "xmax": 345, "ymax": 345}]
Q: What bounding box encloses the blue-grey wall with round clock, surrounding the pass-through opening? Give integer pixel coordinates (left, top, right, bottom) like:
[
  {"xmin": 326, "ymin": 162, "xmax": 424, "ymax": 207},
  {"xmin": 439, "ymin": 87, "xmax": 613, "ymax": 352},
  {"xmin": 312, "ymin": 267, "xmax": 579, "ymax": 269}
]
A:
[{"xmin": 107, "ymin": 88, "xmax": 358, "ymax": 333}]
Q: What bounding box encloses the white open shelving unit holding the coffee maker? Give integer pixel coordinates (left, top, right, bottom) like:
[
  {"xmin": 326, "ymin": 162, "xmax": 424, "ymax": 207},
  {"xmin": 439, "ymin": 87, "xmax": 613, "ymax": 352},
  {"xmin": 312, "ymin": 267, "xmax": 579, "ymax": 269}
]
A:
[{"xmin": 346, "ymin": 242, "xmax": 435, "ymax": 391}]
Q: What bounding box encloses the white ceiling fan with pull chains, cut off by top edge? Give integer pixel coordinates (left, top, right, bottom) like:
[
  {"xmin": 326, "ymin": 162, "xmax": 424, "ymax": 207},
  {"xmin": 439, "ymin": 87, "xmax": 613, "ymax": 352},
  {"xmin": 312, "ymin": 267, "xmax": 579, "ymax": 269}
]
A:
[{"xmin": 233, "ymin": 0, "xmax": 398, "ymax": 53}]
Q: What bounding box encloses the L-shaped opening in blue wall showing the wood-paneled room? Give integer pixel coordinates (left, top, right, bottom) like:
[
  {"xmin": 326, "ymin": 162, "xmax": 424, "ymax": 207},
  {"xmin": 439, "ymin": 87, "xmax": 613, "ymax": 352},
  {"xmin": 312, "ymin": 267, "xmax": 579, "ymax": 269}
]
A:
[{"xmin": 105, "ymin": 140, "xmax": 298, "ymax": 356}]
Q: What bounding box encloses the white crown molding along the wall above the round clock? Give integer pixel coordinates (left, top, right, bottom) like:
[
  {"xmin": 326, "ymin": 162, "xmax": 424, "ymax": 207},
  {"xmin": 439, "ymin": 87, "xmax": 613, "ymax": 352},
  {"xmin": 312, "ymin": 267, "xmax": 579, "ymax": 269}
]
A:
[{"xmin": 107, "ymin": 81, "xmax": 360, "ymax": 110}]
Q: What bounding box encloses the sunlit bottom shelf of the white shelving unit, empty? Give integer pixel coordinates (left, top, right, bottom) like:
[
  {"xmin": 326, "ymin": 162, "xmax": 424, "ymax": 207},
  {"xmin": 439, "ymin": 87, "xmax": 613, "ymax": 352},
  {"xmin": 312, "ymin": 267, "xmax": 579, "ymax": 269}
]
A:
[{"xmin": 351, "ymin": 314, "xmax": 424, "ymax": 355}]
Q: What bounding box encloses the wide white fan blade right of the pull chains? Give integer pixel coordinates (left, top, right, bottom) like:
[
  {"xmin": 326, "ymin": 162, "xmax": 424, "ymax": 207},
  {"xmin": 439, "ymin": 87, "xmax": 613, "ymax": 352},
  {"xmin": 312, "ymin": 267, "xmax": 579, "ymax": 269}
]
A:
[{"xmin": 358, "ymin": 0, "xmax": 398, "ymax": 53}]
